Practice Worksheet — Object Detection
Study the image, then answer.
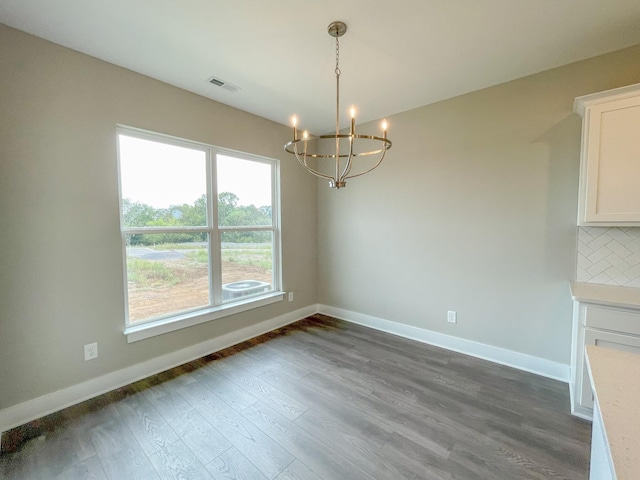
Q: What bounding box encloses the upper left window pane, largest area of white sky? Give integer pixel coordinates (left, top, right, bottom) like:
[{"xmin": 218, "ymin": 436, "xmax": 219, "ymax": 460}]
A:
[{"xmin": 118, "ymin": 134, "xmax": 207, "ymax": 227}]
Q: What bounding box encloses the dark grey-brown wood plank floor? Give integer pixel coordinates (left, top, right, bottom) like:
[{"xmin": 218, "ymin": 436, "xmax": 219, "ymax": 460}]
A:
[{"xmin": 0, "ymin": 315, "xmax": 591, "ymax": 480}]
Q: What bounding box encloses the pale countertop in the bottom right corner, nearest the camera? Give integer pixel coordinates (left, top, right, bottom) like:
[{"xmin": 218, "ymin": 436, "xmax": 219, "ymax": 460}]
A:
[{"xmin": 587, "ymin": 345, "xmax": 640, "ymax": 480}]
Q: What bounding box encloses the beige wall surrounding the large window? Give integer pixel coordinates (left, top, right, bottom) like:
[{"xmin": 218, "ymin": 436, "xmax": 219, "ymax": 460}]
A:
[{"xmin": 0, "ymin": 25, "xmax": 316, "ymax": 409}]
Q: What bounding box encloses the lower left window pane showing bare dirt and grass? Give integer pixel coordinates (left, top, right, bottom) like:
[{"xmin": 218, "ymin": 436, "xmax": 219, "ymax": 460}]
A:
[{"xmin": 125, "ymin": 233, "xmax": 210, "ymax": 323}]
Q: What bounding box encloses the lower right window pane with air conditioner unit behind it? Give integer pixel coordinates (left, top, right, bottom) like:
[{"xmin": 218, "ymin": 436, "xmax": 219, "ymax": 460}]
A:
[{"xmin": 221, "ymin": 231, "xmax": 273, "ymax": 302}]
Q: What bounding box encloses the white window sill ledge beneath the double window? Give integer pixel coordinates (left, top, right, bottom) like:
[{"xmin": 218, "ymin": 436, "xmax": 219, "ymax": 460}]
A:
[{"xmin": 124, "ymin": 292, "xmax": 284, "ymax": 343}]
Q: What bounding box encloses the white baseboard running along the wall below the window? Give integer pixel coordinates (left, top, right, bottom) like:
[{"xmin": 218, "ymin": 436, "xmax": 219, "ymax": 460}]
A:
[{"xmin": 0, "ymin": 305, "xmax": 318, "ymax": 433}]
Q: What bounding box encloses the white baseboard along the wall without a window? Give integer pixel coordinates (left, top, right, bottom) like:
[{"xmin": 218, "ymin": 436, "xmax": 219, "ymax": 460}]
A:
[{"xmin": 318, "ymin": 305, "xmax": 570, "ymax": 383}]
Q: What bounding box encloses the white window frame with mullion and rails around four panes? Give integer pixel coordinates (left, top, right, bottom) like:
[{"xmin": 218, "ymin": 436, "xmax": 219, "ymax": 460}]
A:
[{"xmin": 116, "ymin": 125, "xmax": 284, "ymax": 343}]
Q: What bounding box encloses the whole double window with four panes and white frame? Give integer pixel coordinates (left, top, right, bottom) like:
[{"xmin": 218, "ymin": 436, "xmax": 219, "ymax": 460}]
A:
[{"xmin": 118, "ymin": 128, "xmax": 282, "ymax": 339}]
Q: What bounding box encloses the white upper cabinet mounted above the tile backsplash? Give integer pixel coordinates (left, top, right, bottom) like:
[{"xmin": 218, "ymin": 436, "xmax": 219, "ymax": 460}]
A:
[{"xmin": 574, "ymin": 84, "xmax": 640, "ymax": 226}]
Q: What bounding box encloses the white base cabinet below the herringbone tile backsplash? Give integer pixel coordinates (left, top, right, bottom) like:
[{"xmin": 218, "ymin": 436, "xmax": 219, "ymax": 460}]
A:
[{"xmin": 570, "ymin": 301, "xmax": 640, "ymax": 418}]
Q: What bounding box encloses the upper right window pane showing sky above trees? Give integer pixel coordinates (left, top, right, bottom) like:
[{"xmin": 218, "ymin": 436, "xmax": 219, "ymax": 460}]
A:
[{"xmin": 216, "ymin": 155, "xmax": 272, "ymax": 226}]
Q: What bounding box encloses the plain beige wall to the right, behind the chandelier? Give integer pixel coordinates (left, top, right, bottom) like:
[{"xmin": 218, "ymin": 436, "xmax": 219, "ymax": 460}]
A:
[{"xmin": 318, "ymin": 46, "xmax": 640, "ymax": 364}]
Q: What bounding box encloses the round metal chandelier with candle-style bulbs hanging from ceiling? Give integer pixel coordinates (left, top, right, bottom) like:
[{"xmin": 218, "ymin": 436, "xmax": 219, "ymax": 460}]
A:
[{"xmin": 284, "ymin": 22, "xmax": 391, "ymax": 189}]
